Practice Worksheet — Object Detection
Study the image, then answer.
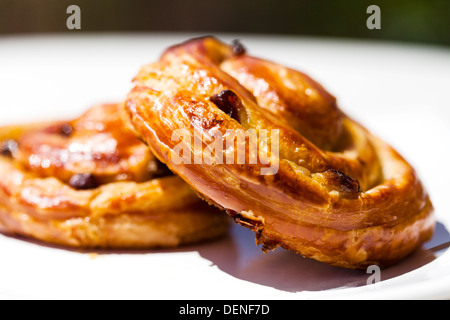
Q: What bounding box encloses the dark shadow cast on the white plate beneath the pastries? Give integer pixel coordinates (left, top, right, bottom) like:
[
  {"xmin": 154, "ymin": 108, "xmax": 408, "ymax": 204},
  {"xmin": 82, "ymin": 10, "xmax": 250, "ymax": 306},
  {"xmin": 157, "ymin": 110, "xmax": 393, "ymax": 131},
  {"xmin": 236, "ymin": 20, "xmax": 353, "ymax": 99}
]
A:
[{"xmin": 1, "ymin": 223, "xmax": 450, "ymax": 292}]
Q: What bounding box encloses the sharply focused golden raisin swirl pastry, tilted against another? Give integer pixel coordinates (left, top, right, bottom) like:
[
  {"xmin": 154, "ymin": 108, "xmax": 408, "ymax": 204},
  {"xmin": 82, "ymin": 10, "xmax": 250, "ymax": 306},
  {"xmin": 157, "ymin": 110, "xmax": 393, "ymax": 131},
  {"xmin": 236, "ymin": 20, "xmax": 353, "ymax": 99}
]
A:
[{"xmin": 126, "ymin": 37, "xmax": 435, "ymax": 268}]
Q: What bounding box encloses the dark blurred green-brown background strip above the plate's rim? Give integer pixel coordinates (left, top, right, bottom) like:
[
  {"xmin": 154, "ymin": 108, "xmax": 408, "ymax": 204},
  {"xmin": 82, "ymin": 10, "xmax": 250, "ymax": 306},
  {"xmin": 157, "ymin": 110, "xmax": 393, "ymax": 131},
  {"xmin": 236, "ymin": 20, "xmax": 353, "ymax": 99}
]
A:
[{"xmin": 0, "ymin": 0, "xmax": 450, "ymax": 46}]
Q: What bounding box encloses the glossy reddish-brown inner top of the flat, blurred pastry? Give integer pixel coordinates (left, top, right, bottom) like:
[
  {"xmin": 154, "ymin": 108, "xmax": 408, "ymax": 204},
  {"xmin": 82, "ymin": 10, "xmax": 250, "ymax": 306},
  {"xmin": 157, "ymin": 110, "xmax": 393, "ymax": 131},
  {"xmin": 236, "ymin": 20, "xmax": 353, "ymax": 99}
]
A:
[{"xmin": 17, "ymin": 104, "xmax": 157, "ymax": 184}]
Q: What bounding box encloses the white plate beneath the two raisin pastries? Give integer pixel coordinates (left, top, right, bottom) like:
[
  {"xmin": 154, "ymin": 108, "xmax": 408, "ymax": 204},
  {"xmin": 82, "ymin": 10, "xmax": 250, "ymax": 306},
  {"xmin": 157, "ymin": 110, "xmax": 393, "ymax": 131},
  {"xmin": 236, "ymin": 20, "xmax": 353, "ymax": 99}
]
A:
[{"xmin": 0, "ymin": 34, "xmax": 450, "ymax": 299}]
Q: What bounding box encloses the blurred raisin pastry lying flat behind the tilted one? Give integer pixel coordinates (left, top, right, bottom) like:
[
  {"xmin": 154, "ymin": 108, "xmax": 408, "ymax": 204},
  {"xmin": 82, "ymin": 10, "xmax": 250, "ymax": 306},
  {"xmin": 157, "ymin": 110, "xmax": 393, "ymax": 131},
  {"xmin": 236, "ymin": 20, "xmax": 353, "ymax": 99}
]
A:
[{"xmin": 0, "ymin": 104, "xmax": 228, "ymax": 249}]
